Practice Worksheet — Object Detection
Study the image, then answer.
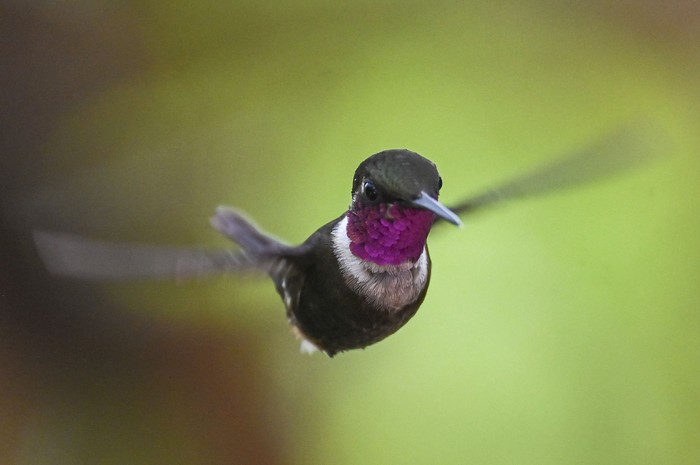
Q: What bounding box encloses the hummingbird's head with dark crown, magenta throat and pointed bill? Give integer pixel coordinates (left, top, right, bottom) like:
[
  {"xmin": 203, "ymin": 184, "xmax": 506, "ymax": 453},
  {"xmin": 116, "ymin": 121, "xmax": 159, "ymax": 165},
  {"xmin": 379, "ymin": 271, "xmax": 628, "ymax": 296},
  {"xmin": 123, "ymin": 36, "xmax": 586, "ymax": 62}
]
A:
[{"xmin": 347, "ymin": 149, "xmax": 462, "ymax": 266}]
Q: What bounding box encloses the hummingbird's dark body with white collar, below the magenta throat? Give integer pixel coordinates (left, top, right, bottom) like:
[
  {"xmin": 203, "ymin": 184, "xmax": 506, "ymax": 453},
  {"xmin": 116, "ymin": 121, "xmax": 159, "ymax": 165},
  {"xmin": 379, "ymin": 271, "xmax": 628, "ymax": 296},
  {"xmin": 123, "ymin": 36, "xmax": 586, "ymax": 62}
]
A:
[{"xmin": 278, "ymin": 215, "xmax": 430, "ymax": 356}]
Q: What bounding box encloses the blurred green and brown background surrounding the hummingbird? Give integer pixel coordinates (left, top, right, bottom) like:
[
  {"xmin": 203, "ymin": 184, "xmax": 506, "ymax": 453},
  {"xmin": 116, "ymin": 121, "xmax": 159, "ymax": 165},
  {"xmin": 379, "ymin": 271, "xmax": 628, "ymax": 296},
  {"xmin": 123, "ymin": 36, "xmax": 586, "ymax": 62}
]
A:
[{"xmin": 0, "ymin": 0, "xmax": 700, "ymax": 465}]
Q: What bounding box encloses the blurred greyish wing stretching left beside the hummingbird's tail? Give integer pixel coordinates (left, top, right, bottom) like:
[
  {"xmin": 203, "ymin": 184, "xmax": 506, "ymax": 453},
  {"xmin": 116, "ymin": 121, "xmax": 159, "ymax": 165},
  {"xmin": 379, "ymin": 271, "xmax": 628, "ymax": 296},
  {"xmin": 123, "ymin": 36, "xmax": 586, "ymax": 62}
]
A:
[{"xmin": 34, "ymin": 231, "xmax": 271, "ymax": 280}]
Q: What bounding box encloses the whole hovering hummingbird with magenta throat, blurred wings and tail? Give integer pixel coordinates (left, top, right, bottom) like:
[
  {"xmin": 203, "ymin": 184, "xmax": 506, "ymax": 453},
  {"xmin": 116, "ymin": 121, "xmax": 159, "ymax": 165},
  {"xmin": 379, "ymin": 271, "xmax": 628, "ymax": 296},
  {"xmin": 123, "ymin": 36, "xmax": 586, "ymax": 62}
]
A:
[{"xmin": 34, "ymin": 130, "xmax": 649, "ymax": 357}]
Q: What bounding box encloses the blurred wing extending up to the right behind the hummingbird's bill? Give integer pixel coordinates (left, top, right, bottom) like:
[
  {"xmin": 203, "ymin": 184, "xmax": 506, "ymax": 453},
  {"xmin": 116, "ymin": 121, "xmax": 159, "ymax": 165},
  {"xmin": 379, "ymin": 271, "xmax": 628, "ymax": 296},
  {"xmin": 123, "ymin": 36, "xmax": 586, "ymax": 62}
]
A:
[{"xmin": 450, "ymin": 126, "xmax": 658, "ymax": 215}]
